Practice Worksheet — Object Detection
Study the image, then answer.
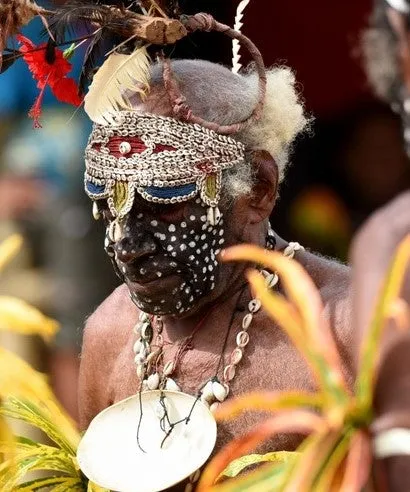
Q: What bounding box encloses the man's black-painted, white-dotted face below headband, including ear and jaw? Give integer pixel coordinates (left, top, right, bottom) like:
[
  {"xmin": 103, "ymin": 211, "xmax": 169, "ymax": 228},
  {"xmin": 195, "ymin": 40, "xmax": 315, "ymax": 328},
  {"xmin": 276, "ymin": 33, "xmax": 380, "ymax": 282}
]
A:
[{"xmin": 99, "ymin": 151, "xmax": 277, "ymax": 318}]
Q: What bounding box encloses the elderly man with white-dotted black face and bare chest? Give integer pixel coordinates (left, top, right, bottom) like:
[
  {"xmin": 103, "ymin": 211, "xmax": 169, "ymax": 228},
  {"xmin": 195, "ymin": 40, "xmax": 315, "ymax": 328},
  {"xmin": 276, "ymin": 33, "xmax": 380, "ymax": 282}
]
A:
[{"xmin": 79, "ymin": 57, "xmax": 353, "ymax": 488}]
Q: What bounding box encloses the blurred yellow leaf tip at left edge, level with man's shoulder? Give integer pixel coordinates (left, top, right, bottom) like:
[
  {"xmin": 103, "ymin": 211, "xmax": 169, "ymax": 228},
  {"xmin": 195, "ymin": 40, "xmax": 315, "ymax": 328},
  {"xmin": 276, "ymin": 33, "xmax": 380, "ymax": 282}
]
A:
[{"xmin": 0, "ymin": 296, "xmax": 59, "ymax": 341}]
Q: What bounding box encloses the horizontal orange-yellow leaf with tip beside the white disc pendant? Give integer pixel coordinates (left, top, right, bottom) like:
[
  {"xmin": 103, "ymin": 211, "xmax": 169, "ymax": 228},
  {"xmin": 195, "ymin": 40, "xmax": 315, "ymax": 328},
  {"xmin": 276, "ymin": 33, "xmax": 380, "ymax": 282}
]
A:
[{"xmin": 214, "ymin": 391, "xmax": 322, "ymax": 421}]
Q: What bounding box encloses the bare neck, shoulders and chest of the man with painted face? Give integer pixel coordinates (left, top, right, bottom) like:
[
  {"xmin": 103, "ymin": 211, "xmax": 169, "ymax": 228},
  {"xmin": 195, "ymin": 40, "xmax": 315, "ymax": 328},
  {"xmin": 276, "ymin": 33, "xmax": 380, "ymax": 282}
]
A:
[{"xmin": 80, "ymin": 242, "xmax": 353, "ymax": 450}]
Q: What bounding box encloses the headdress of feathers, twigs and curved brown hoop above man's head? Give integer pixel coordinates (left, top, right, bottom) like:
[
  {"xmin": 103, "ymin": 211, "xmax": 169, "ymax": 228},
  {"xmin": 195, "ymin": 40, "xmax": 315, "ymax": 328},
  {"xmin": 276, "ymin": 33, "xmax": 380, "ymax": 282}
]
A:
[{"xmin": 0, "ymin": 0, "xmax": 266, "ymax": 134}]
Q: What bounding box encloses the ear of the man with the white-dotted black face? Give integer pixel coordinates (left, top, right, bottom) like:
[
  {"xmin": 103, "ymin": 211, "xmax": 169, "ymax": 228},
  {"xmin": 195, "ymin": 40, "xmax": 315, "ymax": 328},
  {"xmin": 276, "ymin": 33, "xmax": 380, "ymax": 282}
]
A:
[{"xmin": 248, "ymin": 150, "xmax": 279, "ymax": 223}]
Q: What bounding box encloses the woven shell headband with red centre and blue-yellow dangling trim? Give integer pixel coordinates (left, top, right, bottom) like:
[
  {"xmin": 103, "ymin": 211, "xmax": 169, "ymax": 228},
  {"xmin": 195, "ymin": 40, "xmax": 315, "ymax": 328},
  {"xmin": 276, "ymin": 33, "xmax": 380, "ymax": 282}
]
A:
[{"xmin": 85, "ymin": 111, "xmax": 245, "ymax": 225}]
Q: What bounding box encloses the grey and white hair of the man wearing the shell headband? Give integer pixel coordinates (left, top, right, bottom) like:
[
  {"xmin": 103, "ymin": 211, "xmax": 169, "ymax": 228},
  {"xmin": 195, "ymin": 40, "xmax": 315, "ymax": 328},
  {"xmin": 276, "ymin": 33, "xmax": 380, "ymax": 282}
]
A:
[{"xmin": 152, "ymin": 60, "xmax": 311, "ymax": 198}]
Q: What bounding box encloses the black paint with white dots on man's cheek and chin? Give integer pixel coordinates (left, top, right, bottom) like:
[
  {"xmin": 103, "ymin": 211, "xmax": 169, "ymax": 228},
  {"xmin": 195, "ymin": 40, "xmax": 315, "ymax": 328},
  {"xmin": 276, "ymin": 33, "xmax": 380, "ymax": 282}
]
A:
[{"xmin": 117, "ymin": 202, "xmax": 224, "ymax": 315}]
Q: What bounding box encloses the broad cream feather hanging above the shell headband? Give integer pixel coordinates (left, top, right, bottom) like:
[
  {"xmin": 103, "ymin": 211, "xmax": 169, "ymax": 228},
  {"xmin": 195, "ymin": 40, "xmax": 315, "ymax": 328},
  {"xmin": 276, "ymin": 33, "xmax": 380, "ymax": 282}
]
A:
[{"xmin": 84, "ymin": 47, "xmax": 150, "ymax": 124}]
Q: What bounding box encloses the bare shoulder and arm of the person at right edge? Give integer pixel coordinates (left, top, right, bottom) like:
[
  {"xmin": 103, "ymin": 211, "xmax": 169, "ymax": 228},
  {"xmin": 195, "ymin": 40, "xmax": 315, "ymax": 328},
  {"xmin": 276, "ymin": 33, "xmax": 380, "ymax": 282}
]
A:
[{"xmin": 351, "ymin": 192, "xmax": 410, "ymax": 492}]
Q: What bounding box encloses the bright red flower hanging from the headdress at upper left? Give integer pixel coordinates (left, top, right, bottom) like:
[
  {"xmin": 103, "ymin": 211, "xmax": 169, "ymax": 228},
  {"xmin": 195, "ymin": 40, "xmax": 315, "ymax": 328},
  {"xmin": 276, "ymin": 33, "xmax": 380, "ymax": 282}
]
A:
[{"xmin": 17, "ymin": 35, "xmax": 82, "ymax": 128}]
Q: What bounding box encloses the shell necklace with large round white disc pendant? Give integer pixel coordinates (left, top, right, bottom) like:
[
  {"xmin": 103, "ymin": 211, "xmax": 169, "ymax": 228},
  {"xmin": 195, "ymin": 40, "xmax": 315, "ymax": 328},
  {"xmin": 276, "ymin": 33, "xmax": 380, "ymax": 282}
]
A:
[{"xmin": 77, "ymin": 238, "xmax": 303, "ymax": 492}]
